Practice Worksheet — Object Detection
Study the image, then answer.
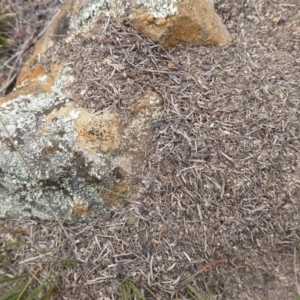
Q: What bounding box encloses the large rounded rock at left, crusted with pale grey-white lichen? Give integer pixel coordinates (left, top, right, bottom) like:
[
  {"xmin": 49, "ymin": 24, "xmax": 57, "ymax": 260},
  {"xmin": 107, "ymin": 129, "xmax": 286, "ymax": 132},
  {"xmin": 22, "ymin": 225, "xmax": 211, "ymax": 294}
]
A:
[{"xmin": 0, "ymin": 82, "xmax": 162, "ymax": 221}]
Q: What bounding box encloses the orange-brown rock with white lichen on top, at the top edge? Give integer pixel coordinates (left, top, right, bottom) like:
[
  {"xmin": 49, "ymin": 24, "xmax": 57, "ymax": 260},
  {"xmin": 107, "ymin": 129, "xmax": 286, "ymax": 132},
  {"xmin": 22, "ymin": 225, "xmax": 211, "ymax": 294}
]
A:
[{"xmin": 72, "ymin": 0, "xmax": 231, "ymax": 48}]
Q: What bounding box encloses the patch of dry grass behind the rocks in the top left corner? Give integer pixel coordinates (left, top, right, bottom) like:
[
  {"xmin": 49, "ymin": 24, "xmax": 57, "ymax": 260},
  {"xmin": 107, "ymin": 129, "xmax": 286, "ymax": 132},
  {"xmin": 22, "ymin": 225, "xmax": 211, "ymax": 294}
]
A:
[{"xmin": 0, "ymin": 0, "xmax": 65, "ymax": 97}]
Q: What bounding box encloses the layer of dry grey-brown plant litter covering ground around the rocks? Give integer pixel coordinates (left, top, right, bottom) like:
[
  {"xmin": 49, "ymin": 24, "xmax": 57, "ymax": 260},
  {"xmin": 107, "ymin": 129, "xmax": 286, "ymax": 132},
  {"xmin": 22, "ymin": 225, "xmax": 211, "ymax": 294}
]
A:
[{"xmin": 0, "ymin": 0, "xmax": 300, "ymax": 299}]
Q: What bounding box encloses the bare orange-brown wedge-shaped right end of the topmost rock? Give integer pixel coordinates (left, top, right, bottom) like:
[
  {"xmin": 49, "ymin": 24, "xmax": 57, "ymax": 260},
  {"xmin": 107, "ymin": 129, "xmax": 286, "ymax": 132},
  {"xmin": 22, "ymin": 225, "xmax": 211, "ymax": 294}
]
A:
[{"xmin": 129, "ymin": 0, "xmax": 231, "ymax": 48}]
